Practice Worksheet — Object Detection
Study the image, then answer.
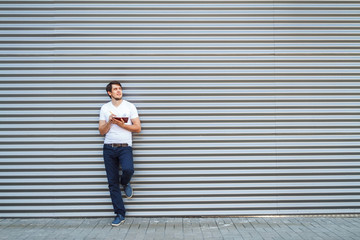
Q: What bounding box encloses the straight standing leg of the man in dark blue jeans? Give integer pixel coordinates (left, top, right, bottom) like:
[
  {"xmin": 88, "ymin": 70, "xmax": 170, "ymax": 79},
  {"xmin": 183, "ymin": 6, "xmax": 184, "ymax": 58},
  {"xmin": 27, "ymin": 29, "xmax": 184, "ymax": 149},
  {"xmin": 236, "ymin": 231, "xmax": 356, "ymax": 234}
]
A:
[{"xmin": 103, "ymin": 145, "xmax": 126, "ymax": 217}]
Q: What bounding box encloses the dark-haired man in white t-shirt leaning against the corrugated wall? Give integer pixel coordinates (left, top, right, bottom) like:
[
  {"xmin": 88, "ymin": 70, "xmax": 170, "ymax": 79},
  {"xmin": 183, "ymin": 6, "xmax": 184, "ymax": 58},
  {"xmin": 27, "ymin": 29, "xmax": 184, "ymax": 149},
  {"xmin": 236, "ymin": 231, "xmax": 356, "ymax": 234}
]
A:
[{"xmin": 99, "ymin": 81, "xmax": 141, "ymax": 226}]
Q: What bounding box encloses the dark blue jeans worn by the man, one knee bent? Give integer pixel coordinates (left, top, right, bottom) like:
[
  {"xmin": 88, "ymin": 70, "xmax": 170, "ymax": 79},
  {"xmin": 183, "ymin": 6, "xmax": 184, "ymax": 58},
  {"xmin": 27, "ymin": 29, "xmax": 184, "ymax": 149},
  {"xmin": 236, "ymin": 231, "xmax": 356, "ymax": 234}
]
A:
[{"xmin": 103, "ymin": 144, "xmax": 134, "ymax": 217}]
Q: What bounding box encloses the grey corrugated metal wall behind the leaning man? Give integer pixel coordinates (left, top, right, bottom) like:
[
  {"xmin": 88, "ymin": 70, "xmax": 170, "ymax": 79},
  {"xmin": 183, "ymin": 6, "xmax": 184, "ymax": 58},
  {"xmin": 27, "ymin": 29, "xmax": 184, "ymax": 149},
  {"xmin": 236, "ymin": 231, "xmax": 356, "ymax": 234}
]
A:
[{"xmin": 0, "ymin": 0, "xmax": 360, "ymax": 217}]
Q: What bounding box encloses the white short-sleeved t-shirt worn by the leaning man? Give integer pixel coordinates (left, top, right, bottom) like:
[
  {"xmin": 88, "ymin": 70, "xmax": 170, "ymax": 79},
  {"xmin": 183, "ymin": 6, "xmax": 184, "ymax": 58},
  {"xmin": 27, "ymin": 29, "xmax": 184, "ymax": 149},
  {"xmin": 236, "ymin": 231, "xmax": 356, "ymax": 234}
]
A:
[{"xmin": 99, "ymin": 100, "xmax": 139, "ymax": 146}]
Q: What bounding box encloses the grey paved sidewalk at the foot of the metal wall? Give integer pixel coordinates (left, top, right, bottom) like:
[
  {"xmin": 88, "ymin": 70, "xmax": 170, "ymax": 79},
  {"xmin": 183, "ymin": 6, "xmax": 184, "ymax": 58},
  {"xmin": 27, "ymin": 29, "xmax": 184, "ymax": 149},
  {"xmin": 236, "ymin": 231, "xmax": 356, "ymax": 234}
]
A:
[{"xmin": 0, "ymin": 217, "xmax": 360, "ymax": 240}]
